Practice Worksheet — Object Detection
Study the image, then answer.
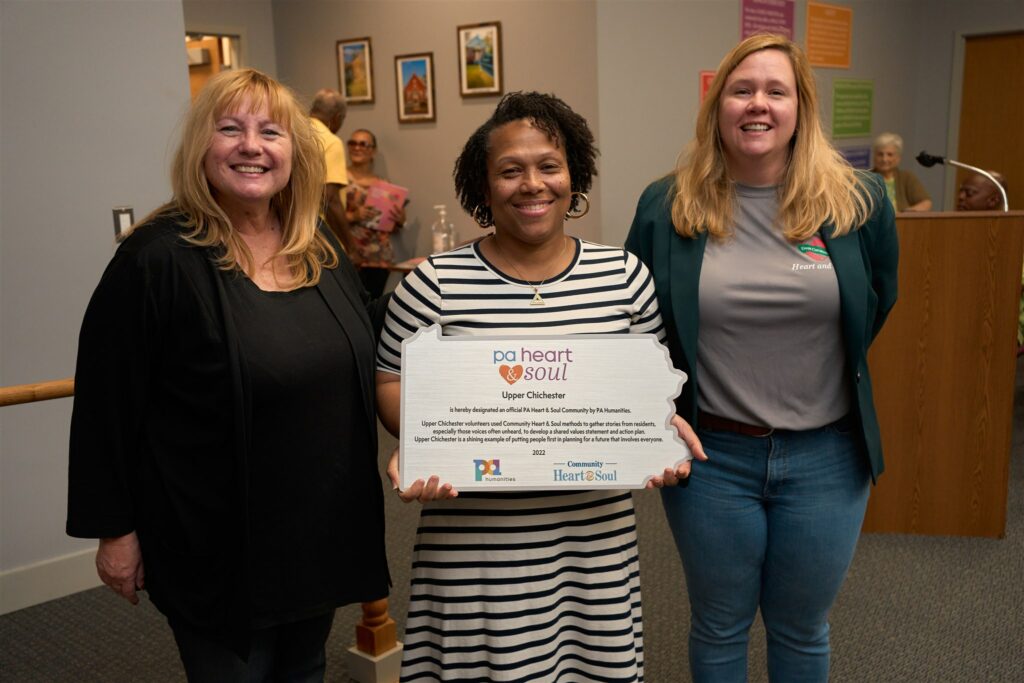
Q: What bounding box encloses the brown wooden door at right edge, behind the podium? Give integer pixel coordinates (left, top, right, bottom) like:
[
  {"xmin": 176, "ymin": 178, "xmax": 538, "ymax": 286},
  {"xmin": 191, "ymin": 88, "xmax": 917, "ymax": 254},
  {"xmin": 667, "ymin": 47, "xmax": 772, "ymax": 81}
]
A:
[{"xmin": 953, "ymin": 31, "xmax": 1024, "ymax": 209}]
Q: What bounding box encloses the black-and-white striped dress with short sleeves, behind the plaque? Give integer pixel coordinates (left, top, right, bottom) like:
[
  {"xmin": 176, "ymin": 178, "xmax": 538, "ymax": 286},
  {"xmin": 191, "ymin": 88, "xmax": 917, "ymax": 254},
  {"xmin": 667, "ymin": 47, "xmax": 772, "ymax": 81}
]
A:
[{"xmin": 378, "ymin": 240, "xmax": 664, "ymax": 683}]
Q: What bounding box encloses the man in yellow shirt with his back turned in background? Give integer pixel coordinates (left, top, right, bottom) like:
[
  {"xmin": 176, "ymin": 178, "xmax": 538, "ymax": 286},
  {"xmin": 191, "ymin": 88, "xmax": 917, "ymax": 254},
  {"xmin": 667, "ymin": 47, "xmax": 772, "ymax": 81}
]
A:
[{"xmin": 309, "ymin": 88, "xmax": 352, "ymax": 252}]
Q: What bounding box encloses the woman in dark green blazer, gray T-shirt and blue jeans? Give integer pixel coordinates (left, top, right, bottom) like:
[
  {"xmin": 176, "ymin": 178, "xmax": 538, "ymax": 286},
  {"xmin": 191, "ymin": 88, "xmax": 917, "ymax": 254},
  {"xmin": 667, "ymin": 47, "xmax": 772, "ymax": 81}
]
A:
[{"xmin": 627, "ymin": 35, "xmax": 897, "ymax": 683}]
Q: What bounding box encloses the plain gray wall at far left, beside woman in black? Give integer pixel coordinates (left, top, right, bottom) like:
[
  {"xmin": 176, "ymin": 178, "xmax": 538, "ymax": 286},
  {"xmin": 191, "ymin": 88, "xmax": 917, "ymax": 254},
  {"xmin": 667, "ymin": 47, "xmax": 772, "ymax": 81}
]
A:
[{"xmin": 0, "ymin": 0, "xmax": 188, "ymax": 612}]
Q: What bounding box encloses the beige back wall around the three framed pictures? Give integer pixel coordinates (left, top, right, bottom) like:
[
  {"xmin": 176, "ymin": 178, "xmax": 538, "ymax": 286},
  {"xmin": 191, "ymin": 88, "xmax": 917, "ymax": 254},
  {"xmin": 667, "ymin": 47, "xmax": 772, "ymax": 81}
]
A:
[{"xmin": 273, "ymin": 0, "xmax": 601, "ymax": 258}]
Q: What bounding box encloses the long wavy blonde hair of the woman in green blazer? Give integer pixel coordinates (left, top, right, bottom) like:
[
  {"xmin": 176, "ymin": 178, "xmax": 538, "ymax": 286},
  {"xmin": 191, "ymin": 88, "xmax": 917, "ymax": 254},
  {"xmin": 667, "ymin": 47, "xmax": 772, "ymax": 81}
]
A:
[{"xmin": 672, "ymin": 34, "xmax": 871, "ymax": 242}]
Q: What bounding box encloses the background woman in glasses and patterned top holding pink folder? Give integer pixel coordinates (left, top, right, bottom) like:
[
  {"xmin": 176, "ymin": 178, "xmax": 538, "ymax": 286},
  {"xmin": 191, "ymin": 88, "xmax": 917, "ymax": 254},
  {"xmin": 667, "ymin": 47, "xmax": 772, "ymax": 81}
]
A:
[{"xmin": 345, "ymin": 129, "xmax": 406, "ymax": 297}]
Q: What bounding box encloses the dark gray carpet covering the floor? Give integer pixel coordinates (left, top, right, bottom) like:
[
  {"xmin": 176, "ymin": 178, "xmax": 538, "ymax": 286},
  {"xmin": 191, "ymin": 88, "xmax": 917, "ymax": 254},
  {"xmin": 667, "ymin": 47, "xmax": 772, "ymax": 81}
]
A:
[{"xmin": 0, "ymin": 362, "xmax": 1024, "ymax": 683}]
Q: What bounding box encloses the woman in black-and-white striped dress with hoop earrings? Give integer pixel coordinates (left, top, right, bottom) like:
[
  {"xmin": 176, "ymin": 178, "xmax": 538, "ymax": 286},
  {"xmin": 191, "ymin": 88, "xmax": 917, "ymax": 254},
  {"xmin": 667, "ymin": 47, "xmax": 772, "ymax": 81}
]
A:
[{"xmin": 377, "ymin": 92, "xmax": 702, "ymax": 681}]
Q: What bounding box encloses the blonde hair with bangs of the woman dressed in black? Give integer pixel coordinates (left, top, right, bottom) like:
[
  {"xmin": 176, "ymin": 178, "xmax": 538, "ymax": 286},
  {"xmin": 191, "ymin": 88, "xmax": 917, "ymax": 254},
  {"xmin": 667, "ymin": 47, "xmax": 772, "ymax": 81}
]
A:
[{"xmin": 167, "ymin": 69, "xmax": 338, "ymax": 289}]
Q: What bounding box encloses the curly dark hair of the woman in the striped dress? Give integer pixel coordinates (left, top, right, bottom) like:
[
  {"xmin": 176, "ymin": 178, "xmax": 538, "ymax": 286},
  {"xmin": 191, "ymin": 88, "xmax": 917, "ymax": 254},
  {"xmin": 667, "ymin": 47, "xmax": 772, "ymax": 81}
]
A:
[{"xmin": 453, "ymin": 92, "xmax": 598, "ymax": 227}]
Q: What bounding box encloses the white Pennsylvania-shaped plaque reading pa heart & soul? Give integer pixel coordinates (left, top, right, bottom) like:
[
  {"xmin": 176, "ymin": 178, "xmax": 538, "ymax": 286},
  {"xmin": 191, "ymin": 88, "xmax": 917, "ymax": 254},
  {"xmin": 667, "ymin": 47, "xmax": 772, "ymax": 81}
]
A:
[{"xmin": 398, "ymin": 326, "xmax": 691, "ymax": 490}]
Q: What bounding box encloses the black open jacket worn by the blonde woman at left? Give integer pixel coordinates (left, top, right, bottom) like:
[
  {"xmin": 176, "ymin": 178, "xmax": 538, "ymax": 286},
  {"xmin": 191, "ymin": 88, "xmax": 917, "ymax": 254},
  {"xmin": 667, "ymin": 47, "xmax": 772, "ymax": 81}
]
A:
[{"xmin": 68, "ymin": 213, "xmax": 390, "ymax": 648}]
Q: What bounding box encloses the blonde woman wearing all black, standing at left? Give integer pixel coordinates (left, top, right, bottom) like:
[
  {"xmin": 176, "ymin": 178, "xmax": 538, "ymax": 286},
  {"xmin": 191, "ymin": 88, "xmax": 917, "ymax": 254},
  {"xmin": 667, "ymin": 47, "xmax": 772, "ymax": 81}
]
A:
[{"xmin": 68, "ymin": 69, "xmax": 390, "ymax": 683}]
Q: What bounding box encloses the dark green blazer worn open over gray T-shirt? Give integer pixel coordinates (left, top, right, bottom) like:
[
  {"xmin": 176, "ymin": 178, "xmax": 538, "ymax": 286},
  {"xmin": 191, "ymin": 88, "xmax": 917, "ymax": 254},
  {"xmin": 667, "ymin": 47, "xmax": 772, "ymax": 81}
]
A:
[{"xmin": 626, "ymin": 174, "xmax": 899, "ymax": 480}]
